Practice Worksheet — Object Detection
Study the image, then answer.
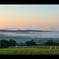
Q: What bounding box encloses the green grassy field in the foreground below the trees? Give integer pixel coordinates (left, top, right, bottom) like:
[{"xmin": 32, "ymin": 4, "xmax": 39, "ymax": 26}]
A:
[{"xmin": 0, "ymin": 46, "xmax": 59, "ymax": 55}]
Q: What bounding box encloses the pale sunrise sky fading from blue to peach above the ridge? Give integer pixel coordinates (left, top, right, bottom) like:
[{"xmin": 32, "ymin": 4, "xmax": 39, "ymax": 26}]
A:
[{"xmin": 0, "ymin": 4, "xmax": 59, "ymax": 31}]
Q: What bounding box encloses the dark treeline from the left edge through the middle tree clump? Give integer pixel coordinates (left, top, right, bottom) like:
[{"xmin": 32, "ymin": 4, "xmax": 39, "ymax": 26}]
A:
[{"xmin": 0, "ymin": 39, "xmax": 36, "ymax": 48}]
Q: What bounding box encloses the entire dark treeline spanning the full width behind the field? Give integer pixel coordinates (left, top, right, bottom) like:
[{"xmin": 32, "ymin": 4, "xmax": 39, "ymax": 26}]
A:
[{"xmin": 0, "ymin": 39, "xmax": 59, "ymax": 48}]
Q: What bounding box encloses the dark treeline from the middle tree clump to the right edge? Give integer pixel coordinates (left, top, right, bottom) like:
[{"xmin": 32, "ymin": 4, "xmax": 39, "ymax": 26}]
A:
[{"xmin": 25, "ymin": 40, "xmax": 59, "ymax": 46}]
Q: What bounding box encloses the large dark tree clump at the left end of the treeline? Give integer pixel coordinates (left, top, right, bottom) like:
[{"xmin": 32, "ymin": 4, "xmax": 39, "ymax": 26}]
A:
[{"xmin": 0, "ymin": 39, "xmax": 16, "ymax": 48}]
